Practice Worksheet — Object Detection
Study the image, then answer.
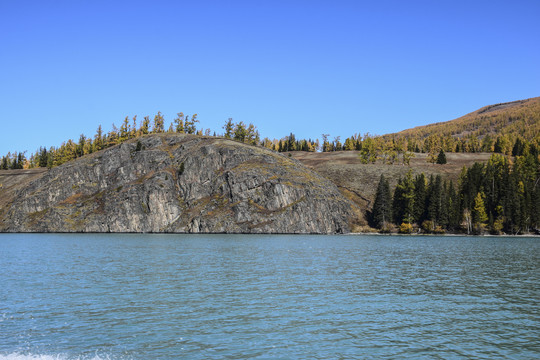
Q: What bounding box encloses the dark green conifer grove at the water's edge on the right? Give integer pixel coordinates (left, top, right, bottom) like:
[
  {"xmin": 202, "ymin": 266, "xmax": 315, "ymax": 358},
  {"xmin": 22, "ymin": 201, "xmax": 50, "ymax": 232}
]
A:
[{"xmin": 368, "ymin": 153, "xmax": 540, "ymax": 234}]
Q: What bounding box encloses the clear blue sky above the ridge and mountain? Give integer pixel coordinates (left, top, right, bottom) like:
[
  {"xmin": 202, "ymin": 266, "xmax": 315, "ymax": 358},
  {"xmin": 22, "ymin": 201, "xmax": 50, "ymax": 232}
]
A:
[{"xmin": 0, "ymin": 0, "xmax": 540, "ymax": 155}]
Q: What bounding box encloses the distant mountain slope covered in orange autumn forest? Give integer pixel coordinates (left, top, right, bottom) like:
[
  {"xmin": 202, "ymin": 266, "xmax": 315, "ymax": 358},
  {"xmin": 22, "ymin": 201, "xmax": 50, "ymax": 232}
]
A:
[{"xmin": 383, "ymin": 97, "xmax": 540, "ymax": 152}]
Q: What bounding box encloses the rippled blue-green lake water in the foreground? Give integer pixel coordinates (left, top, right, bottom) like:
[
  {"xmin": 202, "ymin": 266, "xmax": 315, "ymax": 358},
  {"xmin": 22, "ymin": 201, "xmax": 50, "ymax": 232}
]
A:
[{"xmin": 0, "ymin": 234, "xmax": 540, "ymax": 360}]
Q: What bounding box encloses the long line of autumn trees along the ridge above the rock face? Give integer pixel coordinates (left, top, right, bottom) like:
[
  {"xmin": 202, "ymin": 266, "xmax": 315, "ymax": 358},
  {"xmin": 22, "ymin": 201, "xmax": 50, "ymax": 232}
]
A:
[{"xmin": 4, "ymin": 112, "xmax": 540, "ymax": 169}]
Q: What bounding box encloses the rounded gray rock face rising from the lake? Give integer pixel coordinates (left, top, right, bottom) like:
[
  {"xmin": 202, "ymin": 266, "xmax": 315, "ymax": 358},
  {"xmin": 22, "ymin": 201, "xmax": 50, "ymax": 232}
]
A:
[{"xmin": 0, "ymin": 134, "xmax": 352, "ymax": 234}]
